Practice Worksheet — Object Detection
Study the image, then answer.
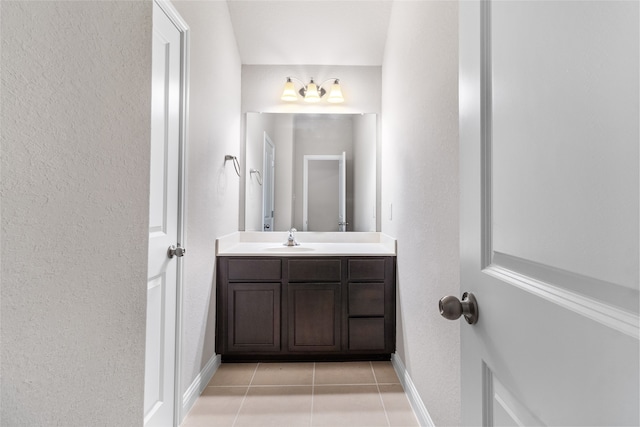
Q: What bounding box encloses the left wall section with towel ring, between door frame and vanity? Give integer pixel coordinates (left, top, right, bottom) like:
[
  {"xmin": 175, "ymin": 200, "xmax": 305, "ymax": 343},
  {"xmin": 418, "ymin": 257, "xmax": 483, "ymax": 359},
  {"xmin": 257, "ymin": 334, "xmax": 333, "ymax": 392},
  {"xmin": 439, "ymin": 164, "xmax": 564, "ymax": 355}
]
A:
[{"xmin": 173, "ymin": 1, "xmax": 242, "ymax": 406}]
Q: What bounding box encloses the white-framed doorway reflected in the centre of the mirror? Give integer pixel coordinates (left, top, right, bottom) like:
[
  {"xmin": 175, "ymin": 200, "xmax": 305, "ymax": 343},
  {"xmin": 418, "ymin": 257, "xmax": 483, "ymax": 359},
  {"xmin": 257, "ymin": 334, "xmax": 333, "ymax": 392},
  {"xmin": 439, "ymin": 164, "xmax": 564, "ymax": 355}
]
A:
[{"xmin": 302, "ymin": 152, "xmax": 347, "ymax": 231}]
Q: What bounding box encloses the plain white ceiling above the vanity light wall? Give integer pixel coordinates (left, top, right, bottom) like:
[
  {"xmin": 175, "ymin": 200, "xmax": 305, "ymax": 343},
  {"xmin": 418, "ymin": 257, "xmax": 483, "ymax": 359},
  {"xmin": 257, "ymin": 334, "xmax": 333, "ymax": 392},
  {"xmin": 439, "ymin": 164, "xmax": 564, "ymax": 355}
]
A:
[{"xmin": 227, "ymin": 0, "xmax": 392, "ymax": 66}]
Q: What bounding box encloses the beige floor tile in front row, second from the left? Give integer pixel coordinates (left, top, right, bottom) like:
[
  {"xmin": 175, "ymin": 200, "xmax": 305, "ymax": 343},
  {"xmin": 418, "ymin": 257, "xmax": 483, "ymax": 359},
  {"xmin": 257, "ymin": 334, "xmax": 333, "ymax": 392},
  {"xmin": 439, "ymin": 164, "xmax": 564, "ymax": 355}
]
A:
[{"xmin": 235, "ymin": 386, "xmax": 312, "ymax": 427}]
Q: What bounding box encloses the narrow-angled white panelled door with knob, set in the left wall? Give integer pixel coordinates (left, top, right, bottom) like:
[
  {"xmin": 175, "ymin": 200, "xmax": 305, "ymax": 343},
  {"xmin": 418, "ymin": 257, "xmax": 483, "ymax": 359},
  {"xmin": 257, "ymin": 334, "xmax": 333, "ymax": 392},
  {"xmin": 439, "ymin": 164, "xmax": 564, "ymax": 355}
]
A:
[{"xmin": 144, "ymin": 2, "xmax": 182, "ymax": 426}]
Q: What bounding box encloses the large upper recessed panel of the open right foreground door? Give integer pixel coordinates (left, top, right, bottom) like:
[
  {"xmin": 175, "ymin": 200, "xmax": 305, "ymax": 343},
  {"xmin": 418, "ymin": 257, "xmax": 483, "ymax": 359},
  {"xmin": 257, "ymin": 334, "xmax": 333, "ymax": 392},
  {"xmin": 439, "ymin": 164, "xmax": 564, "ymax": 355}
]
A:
[{"xmin": 490, "ymin": 1, "xmax": 638, "ymax": 290}]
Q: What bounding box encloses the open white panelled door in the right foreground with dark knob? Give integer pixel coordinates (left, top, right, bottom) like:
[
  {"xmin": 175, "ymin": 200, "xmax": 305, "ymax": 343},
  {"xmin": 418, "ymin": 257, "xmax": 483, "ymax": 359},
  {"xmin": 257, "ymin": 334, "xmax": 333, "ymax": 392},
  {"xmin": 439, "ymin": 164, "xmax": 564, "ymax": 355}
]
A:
[{"xmin": 460, "ymin": 0, "xmax": 640, "ymax": 426}]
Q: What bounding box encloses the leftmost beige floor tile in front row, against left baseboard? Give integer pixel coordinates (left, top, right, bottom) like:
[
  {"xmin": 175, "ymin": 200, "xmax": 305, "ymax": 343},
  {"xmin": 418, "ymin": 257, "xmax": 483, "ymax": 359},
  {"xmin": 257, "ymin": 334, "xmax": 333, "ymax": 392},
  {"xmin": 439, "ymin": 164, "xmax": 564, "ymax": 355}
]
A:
[{"xmin": 181, "ymin": 387, "xmax": 248, "ymax": 427}]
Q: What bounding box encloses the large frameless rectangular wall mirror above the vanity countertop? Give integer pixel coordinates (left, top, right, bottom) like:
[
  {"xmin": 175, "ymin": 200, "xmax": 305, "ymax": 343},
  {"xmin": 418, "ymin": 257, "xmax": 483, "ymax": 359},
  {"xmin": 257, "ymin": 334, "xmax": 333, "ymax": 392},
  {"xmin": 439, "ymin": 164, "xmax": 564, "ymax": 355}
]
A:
[{"xmin": 244, "ymin": 113, "xmax": 379, "ymax": 231}]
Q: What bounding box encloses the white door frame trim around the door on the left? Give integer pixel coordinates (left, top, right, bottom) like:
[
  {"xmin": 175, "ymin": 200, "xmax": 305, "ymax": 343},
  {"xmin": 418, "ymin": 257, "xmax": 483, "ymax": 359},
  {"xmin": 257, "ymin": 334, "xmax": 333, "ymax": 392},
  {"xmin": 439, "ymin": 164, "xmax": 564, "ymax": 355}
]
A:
[{"xmin": 154, "ymin": 0, "xmax": 190, "ymax": 426}]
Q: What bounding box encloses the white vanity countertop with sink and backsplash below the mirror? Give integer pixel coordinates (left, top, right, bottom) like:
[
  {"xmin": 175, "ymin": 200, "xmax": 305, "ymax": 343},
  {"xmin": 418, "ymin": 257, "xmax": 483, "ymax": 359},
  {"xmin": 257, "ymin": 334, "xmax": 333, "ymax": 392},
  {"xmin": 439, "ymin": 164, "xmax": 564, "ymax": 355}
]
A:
[{"xmin": 216, "ymin": 231, "xmax": 396, "ymax": 256}]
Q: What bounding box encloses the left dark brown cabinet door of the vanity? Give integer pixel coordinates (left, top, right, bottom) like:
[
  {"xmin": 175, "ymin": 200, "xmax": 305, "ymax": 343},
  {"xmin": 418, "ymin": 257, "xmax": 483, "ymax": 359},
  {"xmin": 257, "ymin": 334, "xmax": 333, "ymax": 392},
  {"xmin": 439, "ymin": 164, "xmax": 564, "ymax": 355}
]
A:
[{"xmin": 227, "ymin": 283, "xmax": 280, "ymax": 352}]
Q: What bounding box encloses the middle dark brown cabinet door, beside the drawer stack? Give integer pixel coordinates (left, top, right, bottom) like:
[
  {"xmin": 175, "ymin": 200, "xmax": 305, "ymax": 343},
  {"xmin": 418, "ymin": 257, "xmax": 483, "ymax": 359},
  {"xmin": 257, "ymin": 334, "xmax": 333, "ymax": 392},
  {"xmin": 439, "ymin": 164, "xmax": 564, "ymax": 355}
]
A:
[{"xmin": 288, "ymin": 283, "xmax": 341, "ymax": 351}]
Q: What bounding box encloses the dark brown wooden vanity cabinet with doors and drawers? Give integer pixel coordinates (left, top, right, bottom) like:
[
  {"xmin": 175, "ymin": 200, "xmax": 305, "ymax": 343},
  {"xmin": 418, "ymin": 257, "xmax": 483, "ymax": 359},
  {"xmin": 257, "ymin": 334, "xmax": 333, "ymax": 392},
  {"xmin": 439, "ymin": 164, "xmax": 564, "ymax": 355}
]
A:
[{"xmin": 216, "ymin": 256, "xmax": 395, "ymax": 360}]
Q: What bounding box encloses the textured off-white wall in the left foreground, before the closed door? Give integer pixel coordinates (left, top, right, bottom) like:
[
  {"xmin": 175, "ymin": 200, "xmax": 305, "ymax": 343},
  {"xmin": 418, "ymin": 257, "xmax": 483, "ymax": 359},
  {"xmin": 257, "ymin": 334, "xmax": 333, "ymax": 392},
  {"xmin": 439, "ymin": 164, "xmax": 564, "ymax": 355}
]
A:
[{"xmin": 0, "ymin": 1, "xmax": 152, "ymax": 426}]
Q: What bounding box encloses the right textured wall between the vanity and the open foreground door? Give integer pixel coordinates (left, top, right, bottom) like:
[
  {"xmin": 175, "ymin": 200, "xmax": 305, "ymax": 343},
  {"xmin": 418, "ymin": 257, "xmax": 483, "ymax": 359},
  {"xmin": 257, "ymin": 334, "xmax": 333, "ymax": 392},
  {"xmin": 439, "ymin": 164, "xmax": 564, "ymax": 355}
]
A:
[{"xmin": 382, "ymin": 1, "xmax": 460, "ymax": 425}]
